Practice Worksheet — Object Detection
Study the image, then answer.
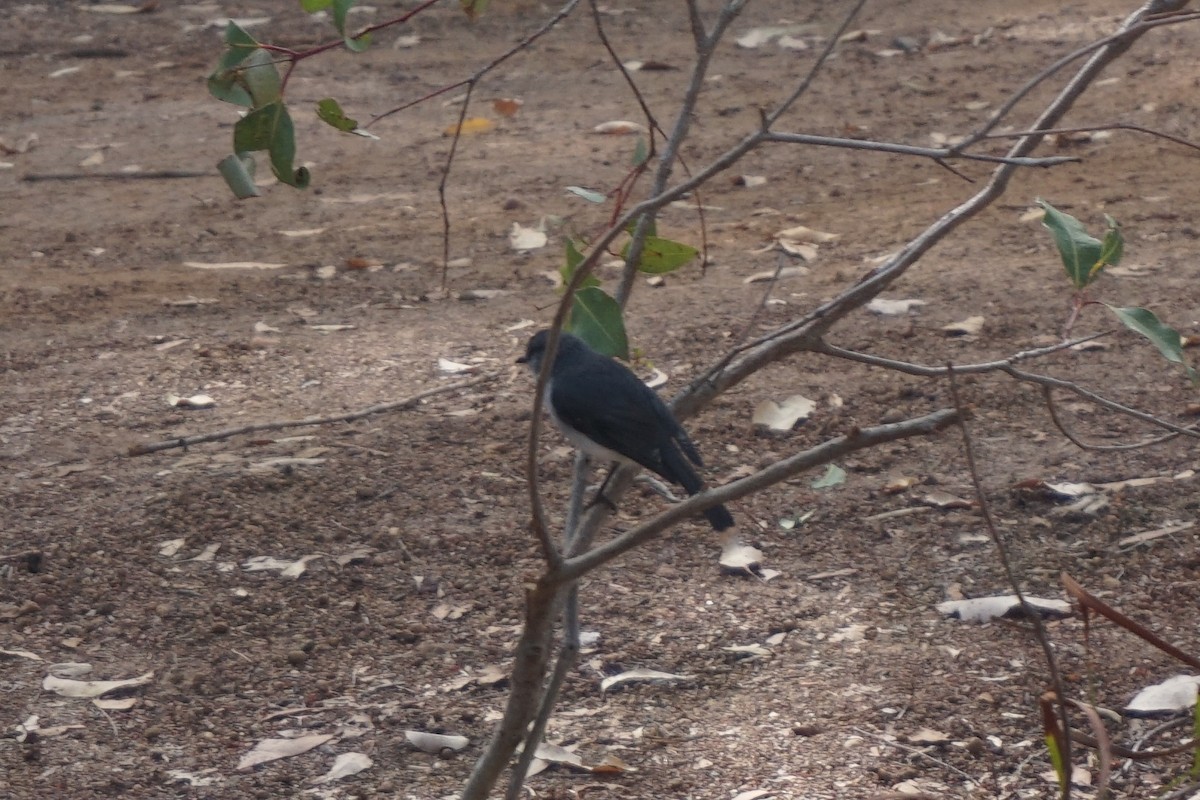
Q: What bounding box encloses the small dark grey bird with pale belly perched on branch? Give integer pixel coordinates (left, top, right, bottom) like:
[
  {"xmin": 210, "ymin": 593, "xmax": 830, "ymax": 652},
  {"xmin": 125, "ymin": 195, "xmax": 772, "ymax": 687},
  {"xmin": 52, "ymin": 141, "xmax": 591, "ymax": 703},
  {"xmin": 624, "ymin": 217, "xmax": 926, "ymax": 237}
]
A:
[{"xmin": 517, "ymin": 330, "xmax": 733, "ymax": 531}]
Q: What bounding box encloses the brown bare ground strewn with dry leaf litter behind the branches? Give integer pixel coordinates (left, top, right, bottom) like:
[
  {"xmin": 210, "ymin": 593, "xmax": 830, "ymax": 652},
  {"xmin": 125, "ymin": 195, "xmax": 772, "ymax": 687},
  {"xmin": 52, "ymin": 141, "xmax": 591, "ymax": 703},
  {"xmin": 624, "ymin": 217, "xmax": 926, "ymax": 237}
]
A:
[{"xmin": 0, "ymin": 0, "xmax": 1200, "ymax": 799}]
